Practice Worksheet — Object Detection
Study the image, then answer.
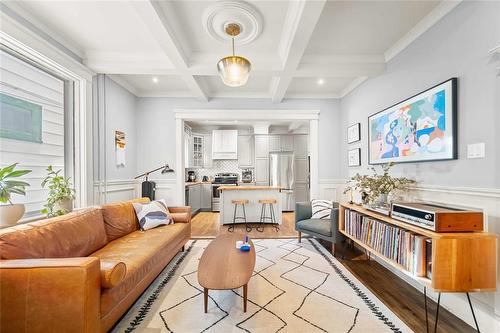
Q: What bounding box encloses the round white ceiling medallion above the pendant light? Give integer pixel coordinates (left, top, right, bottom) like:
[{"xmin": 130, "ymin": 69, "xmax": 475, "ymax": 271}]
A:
[{"xmin": 202, "ymin": 1, "xmax": 263, "ymax": 45}]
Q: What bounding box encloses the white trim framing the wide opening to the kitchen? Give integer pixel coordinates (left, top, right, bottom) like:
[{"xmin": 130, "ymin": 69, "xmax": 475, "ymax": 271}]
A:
[{"xmin": 174, "ymin": 109, "xmax": 320, "ymax": 205}]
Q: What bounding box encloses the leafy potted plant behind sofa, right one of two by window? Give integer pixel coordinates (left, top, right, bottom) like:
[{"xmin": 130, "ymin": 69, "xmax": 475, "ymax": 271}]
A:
[{"xmin": 42, "ymin": 165, "xmax": 75, "ymax": 217}]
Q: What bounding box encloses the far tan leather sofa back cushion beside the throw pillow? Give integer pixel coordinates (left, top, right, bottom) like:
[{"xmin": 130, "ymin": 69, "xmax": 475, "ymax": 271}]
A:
[{"xmin": 102, "ymin": 198, "xmax": 149, "ymax": 242}]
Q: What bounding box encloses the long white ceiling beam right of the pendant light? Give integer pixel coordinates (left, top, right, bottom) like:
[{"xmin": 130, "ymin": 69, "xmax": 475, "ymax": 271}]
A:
[{"xmin": 271, "ymin": 0, "xmax": 326, "ymax": 103}]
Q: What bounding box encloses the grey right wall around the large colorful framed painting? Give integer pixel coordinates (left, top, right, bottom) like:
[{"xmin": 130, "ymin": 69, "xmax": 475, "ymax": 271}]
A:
[{"xmin": 341, "ymin": 2, "xmax": 500, "ymax": 188}]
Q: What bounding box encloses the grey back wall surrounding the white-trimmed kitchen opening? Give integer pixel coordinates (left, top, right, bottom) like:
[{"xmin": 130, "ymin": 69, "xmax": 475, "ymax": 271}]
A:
[{"xmin": 136, "ymin": 97, "xmax": 340, "ymax": 179}]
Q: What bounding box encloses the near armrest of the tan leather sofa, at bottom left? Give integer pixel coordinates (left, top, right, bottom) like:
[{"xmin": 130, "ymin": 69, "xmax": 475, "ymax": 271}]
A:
[{"xmin": 0, "ymin": 257, "xmax": 101, "ymax": 332}]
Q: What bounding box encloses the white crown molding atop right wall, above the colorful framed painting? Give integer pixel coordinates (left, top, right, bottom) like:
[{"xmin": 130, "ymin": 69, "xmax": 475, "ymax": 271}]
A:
[{"xmin": 384, "ymin": 0, "xmax": 462, "ymax": 62}]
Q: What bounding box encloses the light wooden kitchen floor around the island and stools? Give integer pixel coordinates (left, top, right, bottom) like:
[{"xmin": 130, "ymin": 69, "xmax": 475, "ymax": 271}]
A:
[{"xmin": 191, "ymin": 212, "xmax": 298, "ymax": 239}]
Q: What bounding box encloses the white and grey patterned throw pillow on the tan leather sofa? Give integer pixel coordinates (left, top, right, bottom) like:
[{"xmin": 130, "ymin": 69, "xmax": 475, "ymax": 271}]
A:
[{"xmin": 132, "ymin": 199, "xmax": 174, "ymax": 231}]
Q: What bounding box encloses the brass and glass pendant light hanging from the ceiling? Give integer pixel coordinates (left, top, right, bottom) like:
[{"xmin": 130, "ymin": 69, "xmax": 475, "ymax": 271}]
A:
[{"xmin": 217, "ymin": 23, "xmax": 251, "ymax": 87}]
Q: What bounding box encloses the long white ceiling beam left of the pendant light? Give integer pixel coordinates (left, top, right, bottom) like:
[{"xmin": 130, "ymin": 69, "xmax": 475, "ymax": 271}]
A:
[{"xmin": 131, "ymin": 1, "xmax": 208, "ymax": 102}]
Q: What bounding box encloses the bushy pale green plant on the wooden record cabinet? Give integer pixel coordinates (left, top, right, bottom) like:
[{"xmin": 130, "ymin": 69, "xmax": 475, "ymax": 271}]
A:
[{"xmin": 344, "ymin": 162, "xmax": 416, "ymax": 204}]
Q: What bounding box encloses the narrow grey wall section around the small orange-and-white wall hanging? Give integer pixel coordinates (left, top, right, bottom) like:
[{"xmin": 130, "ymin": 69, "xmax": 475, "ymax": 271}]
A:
[{"xmin": 105, "ymin": 76, "xmax": 137, "ymax": 181}]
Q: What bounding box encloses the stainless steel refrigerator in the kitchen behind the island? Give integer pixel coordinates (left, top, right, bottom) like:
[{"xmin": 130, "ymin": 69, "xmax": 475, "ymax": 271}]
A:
[{"xmin": 269, "ymin": 152, "xmax": 295, "ymax": 211}]
